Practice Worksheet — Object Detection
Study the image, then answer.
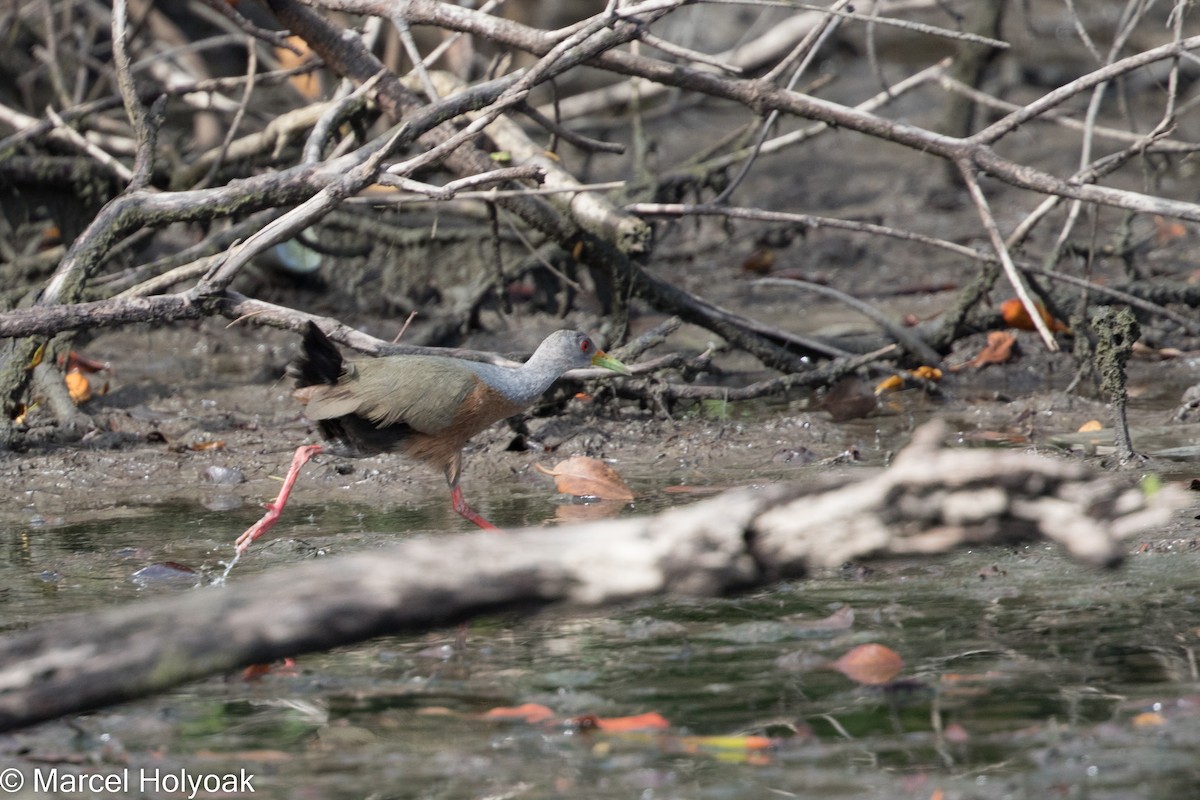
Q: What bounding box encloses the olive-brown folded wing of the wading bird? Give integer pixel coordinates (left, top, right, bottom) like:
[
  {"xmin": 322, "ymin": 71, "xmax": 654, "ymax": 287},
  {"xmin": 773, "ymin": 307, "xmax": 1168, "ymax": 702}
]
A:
[{"xmin": 305, "ymin": 356, "xmax": 479, "ymax": 434}]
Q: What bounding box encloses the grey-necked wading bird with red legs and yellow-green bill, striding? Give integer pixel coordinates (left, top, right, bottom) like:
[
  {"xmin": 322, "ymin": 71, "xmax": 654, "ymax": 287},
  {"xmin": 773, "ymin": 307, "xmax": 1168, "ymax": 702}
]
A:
[{"xmin": 235, "ymin": 320, "xmax": 630, "ymax": 555}]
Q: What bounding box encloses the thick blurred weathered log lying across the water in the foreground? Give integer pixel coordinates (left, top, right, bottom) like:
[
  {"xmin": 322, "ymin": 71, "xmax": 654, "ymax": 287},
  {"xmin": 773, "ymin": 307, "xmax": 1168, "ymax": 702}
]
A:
[{"xmin": 0, "ymin": 423, "xmax": 1183, "ymax": 730}]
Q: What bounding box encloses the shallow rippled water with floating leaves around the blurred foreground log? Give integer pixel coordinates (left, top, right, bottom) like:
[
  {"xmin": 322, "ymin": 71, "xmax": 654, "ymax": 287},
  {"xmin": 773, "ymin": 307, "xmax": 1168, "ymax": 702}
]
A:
[{"xmin": 0, "ymin": 470, "xmax": 1200, "ymax": 798}]
